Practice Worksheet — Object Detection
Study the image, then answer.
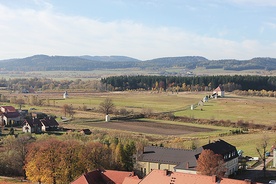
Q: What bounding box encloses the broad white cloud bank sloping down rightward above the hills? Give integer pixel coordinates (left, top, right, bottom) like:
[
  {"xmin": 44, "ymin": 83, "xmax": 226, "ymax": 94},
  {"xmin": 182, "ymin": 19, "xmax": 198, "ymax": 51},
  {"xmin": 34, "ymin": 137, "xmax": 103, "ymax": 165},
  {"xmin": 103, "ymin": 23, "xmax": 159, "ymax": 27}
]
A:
[{"xmin": 0, "ymin": 1, "xmax": 276, "ymax": 60}]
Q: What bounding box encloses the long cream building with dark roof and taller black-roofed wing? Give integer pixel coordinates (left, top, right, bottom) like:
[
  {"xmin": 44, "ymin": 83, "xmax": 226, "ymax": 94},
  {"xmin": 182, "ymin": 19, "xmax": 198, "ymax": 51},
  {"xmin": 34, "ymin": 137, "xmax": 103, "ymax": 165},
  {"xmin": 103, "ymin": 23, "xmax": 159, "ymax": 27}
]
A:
[{"xmin": 136, "ymin": 140, "xmax": 238, "ymax": 176}]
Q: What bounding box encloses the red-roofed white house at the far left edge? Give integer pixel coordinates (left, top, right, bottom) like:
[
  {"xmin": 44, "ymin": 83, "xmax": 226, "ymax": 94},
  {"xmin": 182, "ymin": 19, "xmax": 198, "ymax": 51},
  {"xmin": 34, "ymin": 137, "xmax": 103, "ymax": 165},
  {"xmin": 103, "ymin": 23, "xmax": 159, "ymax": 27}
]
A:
[{"xmin": 0, "ymin": 106, "xmax": 21, "ymax": 126}]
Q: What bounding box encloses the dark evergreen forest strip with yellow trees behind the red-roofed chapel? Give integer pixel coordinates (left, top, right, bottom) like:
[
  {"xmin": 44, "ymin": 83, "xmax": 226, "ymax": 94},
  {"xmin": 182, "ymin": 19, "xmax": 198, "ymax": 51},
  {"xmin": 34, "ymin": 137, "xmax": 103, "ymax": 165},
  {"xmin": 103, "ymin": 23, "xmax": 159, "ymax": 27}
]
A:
[{"xmin": 101, "ymin": 75, "xmax": 276, "ymax": 92}]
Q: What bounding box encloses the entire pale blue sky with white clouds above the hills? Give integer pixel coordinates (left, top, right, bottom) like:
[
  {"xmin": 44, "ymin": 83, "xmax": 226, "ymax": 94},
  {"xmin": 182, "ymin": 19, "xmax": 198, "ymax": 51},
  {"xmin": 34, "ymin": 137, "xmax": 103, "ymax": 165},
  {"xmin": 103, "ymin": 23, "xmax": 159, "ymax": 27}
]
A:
[{"xmin": 0, "ymin": 0, "xmax": 276, "ymax": 60}]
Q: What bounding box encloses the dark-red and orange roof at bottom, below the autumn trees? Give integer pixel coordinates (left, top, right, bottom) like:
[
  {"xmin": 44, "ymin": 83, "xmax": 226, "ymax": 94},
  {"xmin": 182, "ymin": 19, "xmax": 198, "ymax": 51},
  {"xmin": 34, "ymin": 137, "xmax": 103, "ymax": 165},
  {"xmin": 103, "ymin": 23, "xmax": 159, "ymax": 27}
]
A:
[{"xmin": 71, "ymin": 170, "xmax": 140, "ymax": 184}]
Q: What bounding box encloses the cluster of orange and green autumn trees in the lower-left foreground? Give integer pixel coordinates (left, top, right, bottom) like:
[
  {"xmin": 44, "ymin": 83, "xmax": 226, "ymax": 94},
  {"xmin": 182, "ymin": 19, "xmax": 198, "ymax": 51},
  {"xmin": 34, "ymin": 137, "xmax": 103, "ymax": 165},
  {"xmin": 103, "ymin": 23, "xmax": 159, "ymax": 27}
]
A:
[{"xmin": 0, "ymin": 133, "xmax": 144, "ymax": 184}]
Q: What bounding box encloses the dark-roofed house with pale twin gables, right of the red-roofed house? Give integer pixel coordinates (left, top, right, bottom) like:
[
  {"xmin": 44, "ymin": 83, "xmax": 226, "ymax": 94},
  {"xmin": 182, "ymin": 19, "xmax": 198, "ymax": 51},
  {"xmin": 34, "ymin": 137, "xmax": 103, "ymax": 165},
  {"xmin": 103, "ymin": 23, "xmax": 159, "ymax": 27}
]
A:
[{"xmin": 22, "ymin": 117, "xmax": 59, "ymax": 133}]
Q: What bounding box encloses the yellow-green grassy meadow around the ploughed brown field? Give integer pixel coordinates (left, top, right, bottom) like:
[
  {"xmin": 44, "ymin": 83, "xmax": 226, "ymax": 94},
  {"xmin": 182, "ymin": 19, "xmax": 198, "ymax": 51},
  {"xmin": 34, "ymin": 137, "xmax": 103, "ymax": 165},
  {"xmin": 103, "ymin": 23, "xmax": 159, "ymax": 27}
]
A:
[{"xmin": 2, "ymin": 91, "xmax": 276, "ymax": 156}]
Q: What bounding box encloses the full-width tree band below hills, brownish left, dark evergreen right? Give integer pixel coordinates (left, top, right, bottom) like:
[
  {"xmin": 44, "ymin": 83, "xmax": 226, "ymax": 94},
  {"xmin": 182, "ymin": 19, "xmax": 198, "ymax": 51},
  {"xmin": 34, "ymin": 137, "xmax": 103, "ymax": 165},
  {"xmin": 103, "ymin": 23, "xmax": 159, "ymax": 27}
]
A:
[{"xmin": 0, "ymin": 75, "xmax": 276, "ymax": 93}]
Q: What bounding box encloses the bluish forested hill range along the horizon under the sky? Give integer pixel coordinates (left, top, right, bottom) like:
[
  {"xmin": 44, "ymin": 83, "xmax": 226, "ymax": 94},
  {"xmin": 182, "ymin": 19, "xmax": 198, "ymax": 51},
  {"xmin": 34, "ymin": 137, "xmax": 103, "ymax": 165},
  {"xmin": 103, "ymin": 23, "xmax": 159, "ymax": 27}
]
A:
[{"xmin": 0, "ymin": 55, "xmax": 276, "ymax": 71}]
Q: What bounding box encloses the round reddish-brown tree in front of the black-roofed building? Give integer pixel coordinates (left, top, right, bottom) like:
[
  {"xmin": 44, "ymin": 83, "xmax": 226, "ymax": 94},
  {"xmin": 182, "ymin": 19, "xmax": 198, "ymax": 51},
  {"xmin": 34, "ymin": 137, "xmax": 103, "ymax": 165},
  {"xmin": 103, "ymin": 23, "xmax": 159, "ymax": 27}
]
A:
[{"xmin": 196, "ymin": 149, "xmax": 226, "ymax": 177}]
